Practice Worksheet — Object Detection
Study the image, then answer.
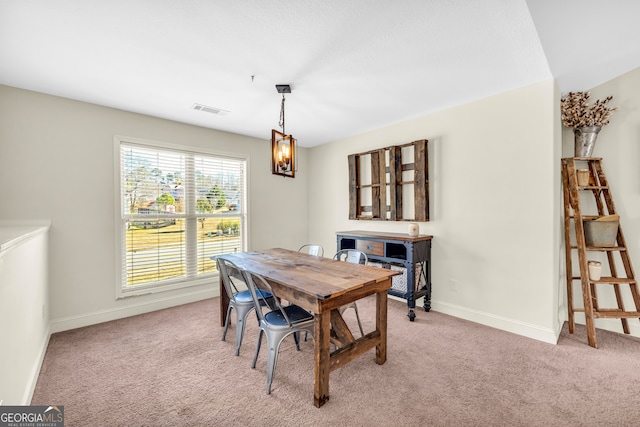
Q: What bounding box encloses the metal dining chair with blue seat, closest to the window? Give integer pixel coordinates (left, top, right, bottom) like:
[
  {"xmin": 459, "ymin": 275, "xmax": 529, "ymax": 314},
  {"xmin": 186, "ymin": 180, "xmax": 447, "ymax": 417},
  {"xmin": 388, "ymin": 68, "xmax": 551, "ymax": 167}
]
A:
[{"xmin": 216, "ymin": 258, "xmax": 273, "ymax": 356}]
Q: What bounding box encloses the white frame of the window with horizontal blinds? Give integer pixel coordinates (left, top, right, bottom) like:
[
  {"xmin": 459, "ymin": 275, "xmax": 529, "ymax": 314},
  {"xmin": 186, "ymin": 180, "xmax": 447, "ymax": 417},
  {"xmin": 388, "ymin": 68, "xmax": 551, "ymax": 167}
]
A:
[{"xmin": 113, "ymin": 135, "xmax": 250, "ymax": 299}]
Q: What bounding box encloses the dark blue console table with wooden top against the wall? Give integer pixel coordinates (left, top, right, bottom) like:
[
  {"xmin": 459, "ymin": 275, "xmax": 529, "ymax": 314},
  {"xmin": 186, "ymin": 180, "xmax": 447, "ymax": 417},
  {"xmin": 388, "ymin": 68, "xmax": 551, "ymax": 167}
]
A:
[{"xmin": 336, "ymin": 231, "xmax": 433, "ymax": 322}]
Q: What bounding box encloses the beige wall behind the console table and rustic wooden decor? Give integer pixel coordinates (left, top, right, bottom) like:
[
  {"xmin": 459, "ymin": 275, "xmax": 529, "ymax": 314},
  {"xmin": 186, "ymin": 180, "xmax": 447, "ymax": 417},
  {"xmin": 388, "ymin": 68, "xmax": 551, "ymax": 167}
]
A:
[{"xmin": 309, "ymin": 80, "xmax": 561, "ymax": 342}]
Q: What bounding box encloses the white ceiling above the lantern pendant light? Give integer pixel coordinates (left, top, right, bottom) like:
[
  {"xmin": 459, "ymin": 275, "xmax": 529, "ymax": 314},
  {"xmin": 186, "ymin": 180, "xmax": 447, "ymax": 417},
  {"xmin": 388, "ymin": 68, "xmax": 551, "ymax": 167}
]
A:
[{"xmin": 0, "ymin": 0, "xmax": 640, "ymax": 147}]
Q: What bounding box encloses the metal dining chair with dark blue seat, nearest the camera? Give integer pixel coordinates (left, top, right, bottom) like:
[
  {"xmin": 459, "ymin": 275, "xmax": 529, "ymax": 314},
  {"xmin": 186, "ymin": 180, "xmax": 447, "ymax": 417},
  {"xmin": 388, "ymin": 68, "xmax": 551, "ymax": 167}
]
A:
[{"xmin": 243, "ymin": 270, "xmax": 315, "ymax": 394}]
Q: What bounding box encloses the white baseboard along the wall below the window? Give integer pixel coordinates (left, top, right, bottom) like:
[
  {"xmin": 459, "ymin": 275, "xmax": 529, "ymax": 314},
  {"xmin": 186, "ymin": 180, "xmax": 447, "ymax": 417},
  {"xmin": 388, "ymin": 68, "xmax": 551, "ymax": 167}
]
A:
[{"xmin": 50, "ymin": 286, "xmax": 219, "ymax": 334}]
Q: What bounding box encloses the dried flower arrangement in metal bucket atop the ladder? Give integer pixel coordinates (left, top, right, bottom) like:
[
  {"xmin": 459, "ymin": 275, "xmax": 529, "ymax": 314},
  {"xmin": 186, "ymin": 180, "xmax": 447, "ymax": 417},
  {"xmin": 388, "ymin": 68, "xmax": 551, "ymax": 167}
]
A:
[{"xmin": 560, "ymin": 92, "xmax": 620, "ymax": 129}]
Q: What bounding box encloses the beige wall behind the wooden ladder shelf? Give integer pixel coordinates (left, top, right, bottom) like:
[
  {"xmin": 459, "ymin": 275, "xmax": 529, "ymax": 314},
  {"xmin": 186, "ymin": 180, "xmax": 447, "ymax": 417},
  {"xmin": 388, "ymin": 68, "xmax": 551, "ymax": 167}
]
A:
[{"xmin": 563, "ymin": 68, "xmax": 640, "ymax": 336}]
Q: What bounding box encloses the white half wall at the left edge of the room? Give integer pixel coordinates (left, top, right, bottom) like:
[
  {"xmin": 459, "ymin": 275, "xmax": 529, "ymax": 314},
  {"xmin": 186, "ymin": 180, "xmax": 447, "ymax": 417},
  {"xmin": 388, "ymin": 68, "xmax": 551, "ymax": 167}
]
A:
[{"xmin": 0, "ymin": 221, "xmax": 49, "ymax": 405}]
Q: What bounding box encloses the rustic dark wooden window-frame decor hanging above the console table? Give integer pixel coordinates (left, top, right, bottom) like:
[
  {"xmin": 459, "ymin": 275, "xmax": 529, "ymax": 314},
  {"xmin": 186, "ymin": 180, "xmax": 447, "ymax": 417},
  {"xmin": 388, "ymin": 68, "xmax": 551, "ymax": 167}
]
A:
[{"xmin": 348, "ymin": 139, "xmax": 429, "ymax": 222}]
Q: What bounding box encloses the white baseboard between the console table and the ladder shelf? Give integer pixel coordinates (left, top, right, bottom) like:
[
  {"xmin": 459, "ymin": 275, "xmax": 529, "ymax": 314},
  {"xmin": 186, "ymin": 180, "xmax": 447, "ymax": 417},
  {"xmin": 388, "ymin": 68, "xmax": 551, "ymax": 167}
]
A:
[{"xmin": 431, "ymin": 300, "xmax": 560, "ymax": 344}]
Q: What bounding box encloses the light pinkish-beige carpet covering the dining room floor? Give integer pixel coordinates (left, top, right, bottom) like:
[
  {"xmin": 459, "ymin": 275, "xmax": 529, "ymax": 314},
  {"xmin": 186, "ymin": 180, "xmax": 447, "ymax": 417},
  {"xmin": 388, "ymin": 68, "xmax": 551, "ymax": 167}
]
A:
[{"xmin": 32, "ymin": 298, "xmax": 640, "ymax": 427}]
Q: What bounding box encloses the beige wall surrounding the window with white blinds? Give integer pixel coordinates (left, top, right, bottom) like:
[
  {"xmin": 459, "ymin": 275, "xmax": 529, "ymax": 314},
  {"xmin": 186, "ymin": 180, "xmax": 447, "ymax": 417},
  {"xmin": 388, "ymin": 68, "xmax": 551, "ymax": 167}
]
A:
[{"xmin": 0, "ymin": 86, "xmax": 309, "ymax": 332}]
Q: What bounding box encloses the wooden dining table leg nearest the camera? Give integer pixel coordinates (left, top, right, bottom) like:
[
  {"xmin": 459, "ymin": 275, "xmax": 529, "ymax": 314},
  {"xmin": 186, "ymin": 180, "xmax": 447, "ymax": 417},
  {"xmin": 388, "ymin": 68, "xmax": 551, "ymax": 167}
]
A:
[{"xmin": 313, "ymin": 312, "xmax": 331, "ymax": 408}]
